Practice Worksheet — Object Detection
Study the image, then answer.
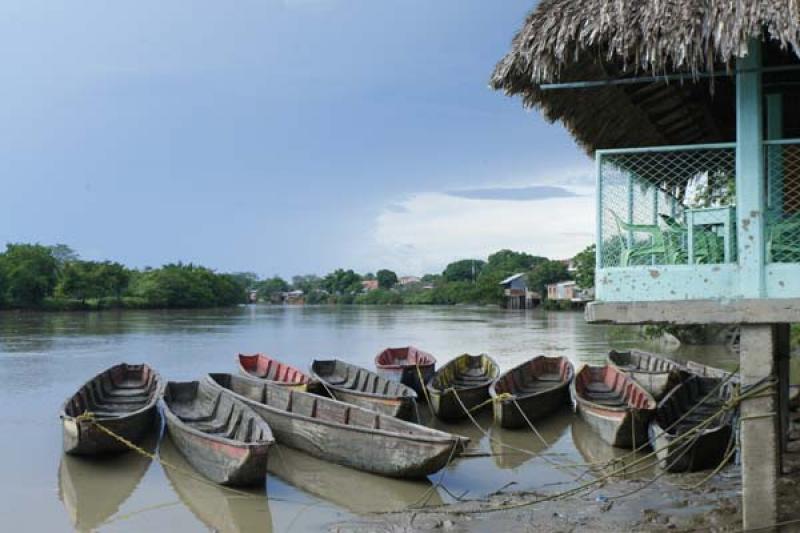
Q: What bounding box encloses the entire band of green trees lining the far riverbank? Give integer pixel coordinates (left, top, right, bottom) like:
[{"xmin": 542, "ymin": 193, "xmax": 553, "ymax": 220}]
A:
[{"xmin": 0, "ymin": 240, "xmax": 594, "ymax": 310}]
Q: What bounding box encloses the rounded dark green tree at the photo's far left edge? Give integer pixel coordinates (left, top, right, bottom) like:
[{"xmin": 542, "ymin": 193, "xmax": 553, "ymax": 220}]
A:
[{"xmin": 0, "ymin": 244, "xmax": 58, "ymax": 307}]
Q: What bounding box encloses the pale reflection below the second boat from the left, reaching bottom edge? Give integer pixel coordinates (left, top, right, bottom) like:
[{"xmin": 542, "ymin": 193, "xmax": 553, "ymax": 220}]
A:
[{"xmin": 159, "ymin": 436, "xmax": 273, "ymax": 533}]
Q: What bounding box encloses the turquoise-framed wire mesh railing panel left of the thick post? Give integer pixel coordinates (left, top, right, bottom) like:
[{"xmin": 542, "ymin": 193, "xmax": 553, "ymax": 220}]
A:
[{"xmin": 597, "ymin": 143, "xmax": 736, "ymax": 267}]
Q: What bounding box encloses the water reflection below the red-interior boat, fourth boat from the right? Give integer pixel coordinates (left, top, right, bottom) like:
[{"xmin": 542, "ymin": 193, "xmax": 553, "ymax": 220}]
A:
[{"xmin": 489, "ymin": 407, "xmax": 575, "ymax": 469}]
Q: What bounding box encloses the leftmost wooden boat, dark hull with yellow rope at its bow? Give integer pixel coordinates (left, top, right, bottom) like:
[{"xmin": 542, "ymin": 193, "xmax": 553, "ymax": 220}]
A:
[{"xmin": 61, "ymin": 363, "xmax": 162, "ymax": 455}]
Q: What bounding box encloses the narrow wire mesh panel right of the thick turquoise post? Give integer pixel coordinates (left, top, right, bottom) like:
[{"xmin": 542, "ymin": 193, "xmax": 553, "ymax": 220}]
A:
[{"xmin": 764, "ymin": 139, "xmax": 800, "ymax": 263}]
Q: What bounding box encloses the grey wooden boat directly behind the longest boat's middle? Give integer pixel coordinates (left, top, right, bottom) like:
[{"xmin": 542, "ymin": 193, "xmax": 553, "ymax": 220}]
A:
[{"xmin": 311, "ymin": 359, "xmax": 417, "ymax": 420}]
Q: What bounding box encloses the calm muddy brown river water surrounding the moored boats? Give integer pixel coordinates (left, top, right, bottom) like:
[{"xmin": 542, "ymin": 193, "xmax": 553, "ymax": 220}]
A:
[{"xmin": 0, "ymin": 306, "xmax": 735, "ymax": 532}]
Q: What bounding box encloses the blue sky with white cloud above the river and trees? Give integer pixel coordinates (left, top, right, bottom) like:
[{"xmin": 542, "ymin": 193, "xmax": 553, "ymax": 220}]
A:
[{"xmin": 0, "ymin": 0, "xmax": 594, "ymax": 276}]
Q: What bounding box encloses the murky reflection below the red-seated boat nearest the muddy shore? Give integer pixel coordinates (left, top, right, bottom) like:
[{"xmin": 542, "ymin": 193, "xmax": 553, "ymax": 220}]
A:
[{"xmin": 572, "ymin": 416, "xmax": 656, "ymax": 479}]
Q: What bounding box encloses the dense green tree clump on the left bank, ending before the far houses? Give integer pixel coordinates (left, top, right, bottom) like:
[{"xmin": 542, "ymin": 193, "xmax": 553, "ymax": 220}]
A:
[{"xmin": 0, "ymin": 244, "xmax": 254, "ymax": 309}]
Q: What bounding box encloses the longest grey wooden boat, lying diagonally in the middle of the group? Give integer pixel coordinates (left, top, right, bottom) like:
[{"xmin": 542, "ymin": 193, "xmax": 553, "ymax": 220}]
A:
[{"xmin": 206, "ymin": 374, "xmax": 468, "ymax": 478}]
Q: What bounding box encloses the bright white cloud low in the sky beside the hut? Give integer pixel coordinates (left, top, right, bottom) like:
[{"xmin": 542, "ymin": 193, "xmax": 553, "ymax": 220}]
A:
[{"xmin": 354, "ymin": 178, "xmax": 595, "ymax": 274}]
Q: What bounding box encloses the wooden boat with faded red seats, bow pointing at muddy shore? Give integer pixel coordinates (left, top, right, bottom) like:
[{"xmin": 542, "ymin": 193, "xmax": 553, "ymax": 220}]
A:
[{"xmin": 572, "ymin": 365, "xmax": 656, "ymax": 448}]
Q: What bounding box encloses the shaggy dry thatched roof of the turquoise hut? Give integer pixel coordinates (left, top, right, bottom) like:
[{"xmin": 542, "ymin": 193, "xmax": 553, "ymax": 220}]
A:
[{"xmin": 491, "ymin": 0, "xmax": 800, "ymax": 152}]
